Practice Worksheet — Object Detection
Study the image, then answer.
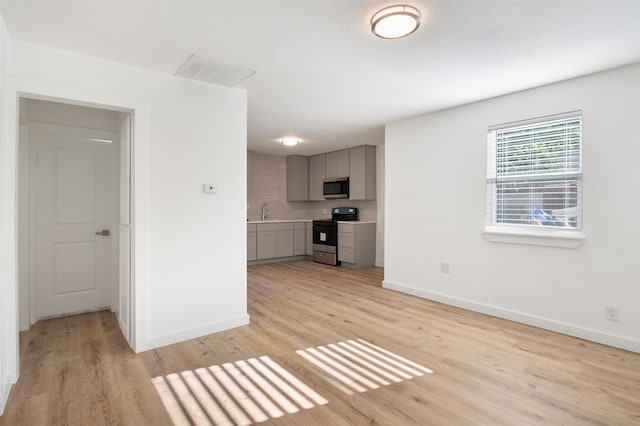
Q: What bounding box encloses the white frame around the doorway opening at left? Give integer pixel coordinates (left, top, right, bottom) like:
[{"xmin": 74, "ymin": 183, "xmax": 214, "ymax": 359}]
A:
[{"xmin": 6, "ymin": 79, "xmax": 149, "ymax": 352}]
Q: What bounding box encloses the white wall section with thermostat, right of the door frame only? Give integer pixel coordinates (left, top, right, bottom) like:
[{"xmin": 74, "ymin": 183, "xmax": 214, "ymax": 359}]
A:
[{"xmin": 147, "ymin": 78, "xmax": 249, "ymax": 346}]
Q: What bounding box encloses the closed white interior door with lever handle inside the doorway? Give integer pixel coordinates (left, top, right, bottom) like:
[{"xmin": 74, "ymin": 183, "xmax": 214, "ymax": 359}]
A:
[{"xmin": 32, "ymin": 126, "xmax": 119, "ymax": 318}]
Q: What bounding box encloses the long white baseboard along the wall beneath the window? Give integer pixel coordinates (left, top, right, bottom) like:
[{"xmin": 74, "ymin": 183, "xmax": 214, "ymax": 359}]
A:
[{"xmin": 382, "ymin": 280, "xmax": 640, "ymax": 352}]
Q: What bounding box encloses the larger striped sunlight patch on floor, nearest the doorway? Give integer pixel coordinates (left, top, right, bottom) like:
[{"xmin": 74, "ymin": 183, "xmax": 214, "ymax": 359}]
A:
[{"xmin": 151, "ymin": 356, "xmax": 328, "ymax": 426}]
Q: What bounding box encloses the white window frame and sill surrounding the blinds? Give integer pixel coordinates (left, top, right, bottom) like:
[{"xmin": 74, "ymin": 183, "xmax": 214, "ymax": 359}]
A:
[{"xmin": 483, "ymin": 110, "xmax": 585, "ymax": 248}]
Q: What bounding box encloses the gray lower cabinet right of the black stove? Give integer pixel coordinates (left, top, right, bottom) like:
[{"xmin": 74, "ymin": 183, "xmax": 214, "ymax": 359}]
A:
[{"xmin": 338, "ymin": 222, "xmax": 376, "ymax": 268}]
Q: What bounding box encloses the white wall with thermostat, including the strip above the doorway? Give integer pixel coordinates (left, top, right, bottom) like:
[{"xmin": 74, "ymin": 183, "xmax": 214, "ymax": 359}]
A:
[{"xmin": 7, "ymin": 41, "xmax": 249, "ymax": 351}]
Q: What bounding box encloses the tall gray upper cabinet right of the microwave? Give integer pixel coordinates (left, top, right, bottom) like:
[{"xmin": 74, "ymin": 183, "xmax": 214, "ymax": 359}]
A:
[{"xmin": 348, "ymin": 145, "xmax": 376, "ymax": 200}]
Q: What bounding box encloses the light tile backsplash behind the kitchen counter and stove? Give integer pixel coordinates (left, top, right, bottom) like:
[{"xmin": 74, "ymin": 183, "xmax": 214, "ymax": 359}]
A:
[{"xmin": 247, "ymin": 151, "xmax": 377, "ymax": 220}]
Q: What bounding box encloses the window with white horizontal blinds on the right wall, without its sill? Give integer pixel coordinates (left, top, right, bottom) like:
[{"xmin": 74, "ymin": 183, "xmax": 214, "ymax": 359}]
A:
[{"xmin": 487, "ymin": 112, "xmax": 582, "ymax": 230}]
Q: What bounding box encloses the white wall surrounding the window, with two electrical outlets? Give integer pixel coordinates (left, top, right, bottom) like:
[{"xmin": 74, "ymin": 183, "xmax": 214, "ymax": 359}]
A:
[{"xmin": 385, "ymin": 65, "xmax": 640, "ymax": 351}]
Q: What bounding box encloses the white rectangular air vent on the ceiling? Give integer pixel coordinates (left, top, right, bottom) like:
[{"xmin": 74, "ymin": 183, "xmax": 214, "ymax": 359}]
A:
[{"xmin": 176, "ymin": 54, "xmax": 256, "ymax": 87}]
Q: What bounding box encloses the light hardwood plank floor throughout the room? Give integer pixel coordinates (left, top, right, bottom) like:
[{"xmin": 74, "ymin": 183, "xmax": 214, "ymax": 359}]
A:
[{"xmin": 0, "ymin": 261, "xmax": 640, "ymax": 426}]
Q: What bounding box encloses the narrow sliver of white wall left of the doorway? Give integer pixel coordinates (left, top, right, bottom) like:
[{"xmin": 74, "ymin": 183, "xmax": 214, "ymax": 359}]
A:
[{"xmin": 0, "ymin": 10, "xmax": 18, "ymax": 415}]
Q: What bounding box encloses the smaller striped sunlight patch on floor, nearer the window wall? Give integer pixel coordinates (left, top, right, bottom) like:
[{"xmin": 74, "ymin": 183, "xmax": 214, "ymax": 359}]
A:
[{"xmin": 296, "ymin": 339, "xmax": 433, "ymax": 395}]
